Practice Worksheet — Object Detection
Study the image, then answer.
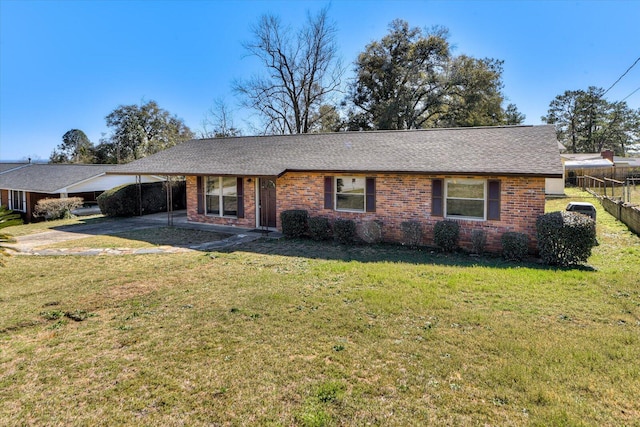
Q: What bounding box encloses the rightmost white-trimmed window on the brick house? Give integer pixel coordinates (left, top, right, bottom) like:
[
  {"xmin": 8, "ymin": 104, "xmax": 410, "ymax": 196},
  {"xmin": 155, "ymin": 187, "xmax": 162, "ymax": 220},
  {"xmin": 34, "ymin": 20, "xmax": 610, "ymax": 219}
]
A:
[{"xmin": 444, "ymin": 179, "xmax": 487, "ymax": 220}]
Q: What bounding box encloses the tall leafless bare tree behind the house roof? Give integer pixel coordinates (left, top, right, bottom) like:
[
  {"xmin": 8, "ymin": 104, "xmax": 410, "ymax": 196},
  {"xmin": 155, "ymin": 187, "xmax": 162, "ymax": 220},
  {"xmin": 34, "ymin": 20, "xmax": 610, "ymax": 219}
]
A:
[{"xmin": 233, "ymin": 8, "xmax": 344, "ymax": 134}]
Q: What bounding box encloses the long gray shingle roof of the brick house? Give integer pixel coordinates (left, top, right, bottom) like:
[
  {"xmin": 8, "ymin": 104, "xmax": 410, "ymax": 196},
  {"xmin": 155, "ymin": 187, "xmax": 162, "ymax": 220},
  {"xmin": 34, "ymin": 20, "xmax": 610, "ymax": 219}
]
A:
[{"xmin": 111, "ymin": 125, "xmax": 562, "ymax": 177}]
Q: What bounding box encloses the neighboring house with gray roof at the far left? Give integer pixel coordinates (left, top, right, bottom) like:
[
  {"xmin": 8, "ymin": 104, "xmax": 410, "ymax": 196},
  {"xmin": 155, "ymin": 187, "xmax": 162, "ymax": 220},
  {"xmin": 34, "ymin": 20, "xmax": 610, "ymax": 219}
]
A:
[{"xmin": 0, "ymin": 163, "xmax": 163, "ymax": 221}]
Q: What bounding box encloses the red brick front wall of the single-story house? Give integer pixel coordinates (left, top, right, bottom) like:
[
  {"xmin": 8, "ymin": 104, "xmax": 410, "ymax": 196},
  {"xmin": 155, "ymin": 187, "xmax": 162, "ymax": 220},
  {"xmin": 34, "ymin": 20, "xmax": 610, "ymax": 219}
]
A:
[{"xmin": 187, "ymin": 172, "xmax": 545, "ymax": 252}]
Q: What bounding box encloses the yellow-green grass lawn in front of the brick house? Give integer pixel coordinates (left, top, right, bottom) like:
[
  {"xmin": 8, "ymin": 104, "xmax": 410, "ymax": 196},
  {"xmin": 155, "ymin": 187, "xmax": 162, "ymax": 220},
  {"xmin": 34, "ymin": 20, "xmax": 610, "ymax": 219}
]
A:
[{"xmin": 0, "ymin": 192, "xmax": 640, "ymax": 426}]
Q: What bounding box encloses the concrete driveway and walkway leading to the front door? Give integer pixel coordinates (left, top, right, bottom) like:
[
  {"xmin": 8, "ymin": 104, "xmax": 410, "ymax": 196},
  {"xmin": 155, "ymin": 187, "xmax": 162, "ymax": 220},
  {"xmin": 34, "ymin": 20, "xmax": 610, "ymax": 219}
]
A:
[{"xmin": 5, "ymin": 211, "xmax": 282, "ymax": 256}]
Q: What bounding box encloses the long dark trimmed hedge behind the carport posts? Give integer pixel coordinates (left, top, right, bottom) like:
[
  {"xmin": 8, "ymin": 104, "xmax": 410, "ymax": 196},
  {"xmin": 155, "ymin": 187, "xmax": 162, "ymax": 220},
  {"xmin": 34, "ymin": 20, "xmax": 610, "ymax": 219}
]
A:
[{"xmin": 97, "ymin": 181, "xmax": 186, "ymax": 216}]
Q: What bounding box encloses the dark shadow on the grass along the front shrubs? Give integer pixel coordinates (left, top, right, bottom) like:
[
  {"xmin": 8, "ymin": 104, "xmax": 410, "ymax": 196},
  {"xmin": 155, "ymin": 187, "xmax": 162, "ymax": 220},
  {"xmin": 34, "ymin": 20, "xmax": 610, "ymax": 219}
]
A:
[{"xmin": 218, "ymin": 238, "xmax": 595, "ymax": 271}]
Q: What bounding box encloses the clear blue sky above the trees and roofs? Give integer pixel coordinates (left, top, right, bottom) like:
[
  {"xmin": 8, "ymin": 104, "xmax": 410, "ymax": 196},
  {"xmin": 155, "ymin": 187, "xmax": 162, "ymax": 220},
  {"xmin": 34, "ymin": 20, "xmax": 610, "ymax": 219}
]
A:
[{"xmin": 0, "ymin": 0, "xmax": 640, "ymax": 160}]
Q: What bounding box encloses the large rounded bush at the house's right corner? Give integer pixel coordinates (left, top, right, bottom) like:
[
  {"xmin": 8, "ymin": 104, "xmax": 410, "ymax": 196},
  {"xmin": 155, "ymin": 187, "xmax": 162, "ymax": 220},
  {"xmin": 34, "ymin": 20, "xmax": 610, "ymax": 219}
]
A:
[{"xmin": 536, "ymin": 211, "xmax": 598, "ymax": 266}]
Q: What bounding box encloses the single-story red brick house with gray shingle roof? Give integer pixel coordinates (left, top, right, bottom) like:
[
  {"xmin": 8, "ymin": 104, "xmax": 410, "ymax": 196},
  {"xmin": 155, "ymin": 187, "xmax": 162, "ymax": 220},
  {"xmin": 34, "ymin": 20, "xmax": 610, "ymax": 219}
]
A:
[{"xmin": 109, "ymin": 125, "xmax": 562, "ymax": 251}]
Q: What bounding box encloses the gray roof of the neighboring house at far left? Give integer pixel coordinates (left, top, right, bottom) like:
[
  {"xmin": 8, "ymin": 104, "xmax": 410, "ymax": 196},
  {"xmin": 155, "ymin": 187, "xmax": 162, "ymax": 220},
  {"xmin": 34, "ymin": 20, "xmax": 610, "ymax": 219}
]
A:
[{"xmin": 0, "ymin": 163, "xmax": 117, "ymax": 193}]
